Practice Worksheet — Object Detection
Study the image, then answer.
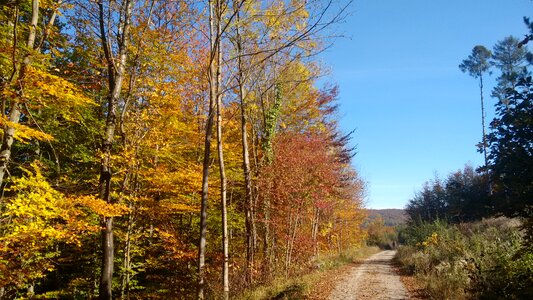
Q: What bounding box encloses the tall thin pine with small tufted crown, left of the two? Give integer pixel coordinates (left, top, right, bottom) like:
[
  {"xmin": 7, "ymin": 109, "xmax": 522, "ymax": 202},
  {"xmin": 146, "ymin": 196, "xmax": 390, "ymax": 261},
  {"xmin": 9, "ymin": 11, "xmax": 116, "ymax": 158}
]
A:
[{"xmin": 459, "ymin": 45, "xmax": 492, "ymax": 167}]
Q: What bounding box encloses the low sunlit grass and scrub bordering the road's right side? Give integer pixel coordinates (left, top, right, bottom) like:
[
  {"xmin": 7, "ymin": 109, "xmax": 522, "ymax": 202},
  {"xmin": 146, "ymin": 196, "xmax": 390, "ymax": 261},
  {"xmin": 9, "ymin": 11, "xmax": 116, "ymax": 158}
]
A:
[{"xmin": 396, "ymin": 218, "xmax": 533, "ymax": 299}]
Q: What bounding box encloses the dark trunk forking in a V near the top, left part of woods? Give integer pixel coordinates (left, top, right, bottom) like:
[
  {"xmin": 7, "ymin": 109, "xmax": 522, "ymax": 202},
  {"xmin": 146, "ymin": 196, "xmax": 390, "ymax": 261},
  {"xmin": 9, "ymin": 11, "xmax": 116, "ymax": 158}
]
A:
[{"xmin": 98, "ymin": 0, "xmax": 133, "ymax": 299}]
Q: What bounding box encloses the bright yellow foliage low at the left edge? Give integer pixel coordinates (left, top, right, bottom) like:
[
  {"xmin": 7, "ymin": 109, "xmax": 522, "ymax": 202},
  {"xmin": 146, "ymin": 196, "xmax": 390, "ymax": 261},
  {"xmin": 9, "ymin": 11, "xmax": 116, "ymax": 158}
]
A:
[{"xmin": 0, "ymin": 162, "xmax": 96, "ymax": 286}]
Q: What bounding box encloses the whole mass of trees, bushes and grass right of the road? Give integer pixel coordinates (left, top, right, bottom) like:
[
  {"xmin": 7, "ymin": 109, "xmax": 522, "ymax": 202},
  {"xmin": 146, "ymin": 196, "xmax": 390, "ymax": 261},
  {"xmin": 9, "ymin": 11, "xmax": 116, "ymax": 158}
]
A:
[{"xmin": 396, "ymin": 18, "xmax": 533, "ymax": 299}]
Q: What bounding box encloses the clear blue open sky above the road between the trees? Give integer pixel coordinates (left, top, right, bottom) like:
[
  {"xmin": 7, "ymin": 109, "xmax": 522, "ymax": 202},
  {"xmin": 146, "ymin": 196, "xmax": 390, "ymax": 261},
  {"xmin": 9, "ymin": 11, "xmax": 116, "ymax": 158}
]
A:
[{"xmin": 322, "ymin": 0, "xmax": 533, "ymax": 209}]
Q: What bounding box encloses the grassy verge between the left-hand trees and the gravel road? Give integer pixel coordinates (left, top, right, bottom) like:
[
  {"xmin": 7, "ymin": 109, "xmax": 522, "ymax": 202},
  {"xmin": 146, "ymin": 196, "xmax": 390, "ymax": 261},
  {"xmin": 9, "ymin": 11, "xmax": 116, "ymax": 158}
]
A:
[{"xmin": 236, "ymin": 247, "xmax": 380, "ymax": 300}]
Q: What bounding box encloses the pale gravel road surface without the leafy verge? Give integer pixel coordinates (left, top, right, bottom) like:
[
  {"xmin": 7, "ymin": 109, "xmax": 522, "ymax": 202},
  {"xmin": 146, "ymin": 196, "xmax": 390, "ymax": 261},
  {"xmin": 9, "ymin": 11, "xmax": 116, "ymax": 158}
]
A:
[{"xmin": 328, "ymin": 251, "xmax": 409, "ymax": 300}]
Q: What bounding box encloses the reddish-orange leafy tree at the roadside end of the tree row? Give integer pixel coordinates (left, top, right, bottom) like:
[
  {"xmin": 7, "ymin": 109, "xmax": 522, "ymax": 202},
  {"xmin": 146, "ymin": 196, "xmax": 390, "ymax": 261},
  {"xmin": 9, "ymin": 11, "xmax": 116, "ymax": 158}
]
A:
[{"xmin": 259, "ymin": 133, "xmax": 363, "ymax": 265}]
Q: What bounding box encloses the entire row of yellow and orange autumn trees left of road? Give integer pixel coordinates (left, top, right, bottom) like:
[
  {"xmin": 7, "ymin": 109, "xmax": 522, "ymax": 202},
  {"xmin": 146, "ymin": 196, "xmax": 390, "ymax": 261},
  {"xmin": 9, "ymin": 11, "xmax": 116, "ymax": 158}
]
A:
[{"xmin": 0, "ymin": 0, "xmax": 364, "ymax": 299}]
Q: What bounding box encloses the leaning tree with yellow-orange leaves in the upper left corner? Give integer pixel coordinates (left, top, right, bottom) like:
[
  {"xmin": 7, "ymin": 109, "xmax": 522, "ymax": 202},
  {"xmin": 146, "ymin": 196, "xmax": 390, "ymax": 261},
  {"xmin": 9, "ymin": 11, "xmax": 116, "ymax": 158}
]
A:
[{"xmin": 0, "ymin": 0, "xmax": 68, "ymax": 188}]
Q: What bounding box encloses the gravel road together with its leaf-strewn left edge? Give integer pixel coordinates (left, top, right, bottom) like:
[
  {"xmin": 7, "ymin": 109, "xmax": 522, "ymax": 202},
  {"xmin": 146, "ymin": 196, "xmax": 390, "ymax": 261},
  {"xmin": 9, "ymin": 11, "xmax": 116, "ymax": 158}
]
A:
[{"xmin": 309, "ymin": 251, "xmax": 414, "ymax": 300}]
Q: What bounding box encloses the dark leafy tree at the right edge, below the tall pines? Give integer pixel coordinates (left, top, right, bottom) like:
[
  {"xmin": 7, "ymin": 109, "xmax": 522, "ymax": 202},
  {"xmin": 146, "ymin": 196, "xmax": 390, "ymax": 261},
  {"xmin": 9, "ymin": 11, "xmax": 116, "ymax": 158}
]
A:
[{"xmin": 488, "ymin": 76, "xmax": 533, "ymax": 216}]
